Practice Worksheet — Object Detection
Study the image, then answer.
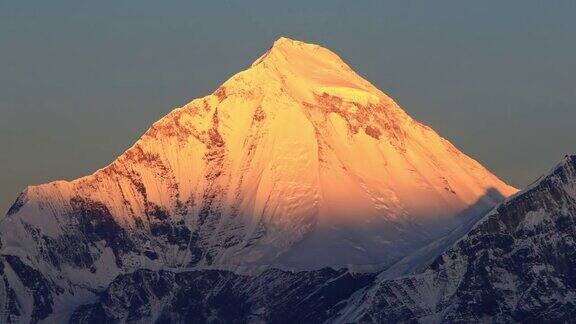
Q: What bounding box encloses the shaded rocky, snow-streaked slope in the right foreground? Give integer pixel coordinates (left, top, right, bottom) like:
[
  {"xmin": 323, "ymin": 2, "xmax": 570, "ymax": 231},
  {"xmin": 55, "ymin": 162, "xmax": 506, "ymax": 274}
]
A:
[{"xmin": 337, "ymin": 156, "xmax": 576, "ymax": 323}]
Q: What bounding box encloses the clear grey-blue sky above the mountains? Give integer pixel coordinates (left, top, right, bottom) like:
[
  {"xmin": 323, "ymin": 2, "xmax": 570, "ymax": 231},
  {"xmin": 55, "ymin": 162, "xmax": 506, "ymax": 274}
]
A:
[{"xmin": 0, "ymin": 0, "xmax": 576, "ymax": 214}]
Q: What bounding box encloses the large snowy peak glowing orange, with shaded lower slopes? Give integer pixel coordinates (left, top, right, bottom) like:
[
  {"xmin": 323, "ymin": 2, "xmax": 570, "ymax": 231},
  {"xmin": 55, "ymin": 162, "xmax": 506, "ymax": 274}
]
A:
[{"xmin": 0, "ymin": 38, "xmax": 516, "ymax": 322}]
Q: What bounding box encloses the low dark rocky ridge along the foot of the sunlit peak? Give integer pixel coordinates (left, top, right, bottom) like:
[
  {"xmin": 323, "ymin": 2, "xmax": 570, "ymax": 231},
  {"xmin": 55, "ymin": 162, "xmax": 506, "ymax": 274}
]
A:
[{"xmin": 71, "ymin": 269, "xmax": 374, "ymax": 323}]
